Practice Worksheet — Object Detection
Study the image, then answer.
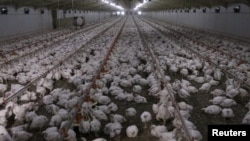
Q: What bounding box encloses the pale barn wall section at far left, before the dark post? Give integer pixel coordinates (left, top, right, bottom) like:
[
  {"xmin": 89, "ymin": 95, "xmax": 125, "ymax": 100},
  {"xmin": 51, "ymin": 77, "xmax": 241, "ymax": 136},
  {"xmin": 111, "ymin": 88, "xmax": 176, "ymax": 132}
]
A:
[{"xmin": 0, "ymin": 6, "xmax": 52, "ymax": 38}]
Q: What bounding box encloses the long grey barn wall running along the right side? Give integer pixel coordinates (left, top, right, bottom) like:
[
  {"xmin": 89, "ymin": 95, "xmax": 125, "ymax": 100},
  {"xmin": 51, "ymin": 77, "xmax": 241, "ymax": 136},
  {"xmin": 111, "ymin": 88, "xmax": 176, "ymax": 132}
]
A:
[{"xmin": 142, "ymin": 4, "xmax": 250, "ymax": 39}]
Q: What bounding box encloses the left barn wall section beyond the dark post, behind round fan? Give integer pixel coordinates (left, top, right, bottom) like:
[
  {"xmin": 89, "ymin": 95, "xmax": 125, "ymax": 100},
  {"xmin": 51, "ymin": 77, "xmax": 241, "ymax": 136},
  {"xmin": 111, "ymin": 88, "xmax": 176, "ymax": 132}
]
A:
[{"xmin": 57, "ymin": 10, "xmax": 111, "ymax": 27}]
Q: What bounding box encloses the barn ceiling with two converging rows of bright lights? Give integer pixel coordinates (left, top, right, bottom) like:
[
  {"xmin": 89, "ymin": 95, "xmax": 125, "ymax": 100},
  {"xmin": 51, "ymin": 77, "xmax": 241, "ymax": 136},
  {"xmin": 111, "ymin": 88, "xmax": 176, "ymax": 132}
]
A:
[{"xmin": 0, "ymin": 0, "xmax": 250, "ymax": 11}]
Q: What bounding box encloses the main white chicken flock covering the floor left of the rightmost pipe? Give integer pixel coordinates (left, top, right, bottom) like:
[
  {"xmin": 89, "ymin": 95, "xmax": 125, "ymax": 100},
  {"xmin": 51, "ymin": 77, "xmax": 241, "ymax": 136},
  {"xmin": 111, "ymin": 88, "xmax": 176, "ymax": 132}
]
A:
[{"xmin": 0, "ymin": 16, "xmax": 250, "ymax": 141}]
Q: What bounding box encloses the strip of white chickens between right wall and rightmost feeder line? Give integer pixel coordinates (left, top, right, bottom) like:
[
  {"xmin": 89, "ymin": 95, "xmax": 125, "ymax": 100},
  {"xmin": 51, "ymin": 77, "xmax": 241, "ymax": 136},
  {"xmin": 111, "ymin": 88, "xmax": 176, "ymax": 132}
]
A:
[{"xmin": 146, "ymin": 18, "xmax": 250, "ymax": 87}]
